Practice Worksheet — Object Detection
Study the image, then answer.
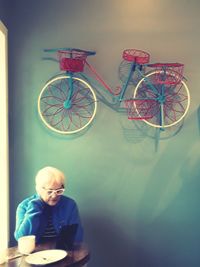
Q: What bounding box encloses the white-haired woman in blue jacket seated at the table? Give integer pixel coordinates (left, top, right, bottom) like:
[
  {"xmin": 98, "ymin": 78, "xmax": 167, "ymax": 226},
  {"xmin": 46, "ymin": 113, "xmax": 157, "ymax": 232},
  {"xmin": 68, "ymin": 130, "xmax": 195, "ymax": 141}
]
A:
[{"xmin": 14, "ymin": 167, "xmax": 83, "ymax": 248}]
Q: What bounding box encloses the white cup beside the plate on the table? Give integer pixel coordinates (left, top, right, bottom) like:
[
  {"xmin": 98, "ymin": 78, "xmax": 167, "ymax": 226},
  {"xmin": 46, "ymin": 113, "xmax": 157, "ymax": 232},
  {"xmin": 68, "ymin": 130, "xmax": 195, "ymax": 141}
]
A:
[{"xmin": 18, "ymin": 235, "xmax": 35, "ymax": 254}]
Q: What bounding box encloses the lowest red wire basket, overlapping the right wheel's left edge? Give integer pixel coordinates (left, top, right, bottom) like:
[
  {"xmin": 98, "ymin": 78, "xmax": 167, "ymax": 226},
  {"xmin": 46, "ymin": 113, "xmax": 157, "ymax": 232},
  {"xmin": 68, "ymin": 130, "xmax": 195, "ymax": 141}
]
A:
[{"xmin": 124, "ymin": 99, "xmax": 156, "ymax": 120}]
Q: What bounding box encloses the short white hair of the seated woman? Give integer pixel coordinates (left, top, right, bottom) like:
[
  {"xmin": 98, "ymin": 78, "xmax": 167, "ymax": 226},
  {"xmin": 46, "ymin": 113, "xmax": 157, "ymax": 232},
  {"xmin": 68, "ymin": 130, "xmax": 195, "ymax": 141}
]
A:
[{"xmin": 35, "ymin": 166, "xmax": 65, "ymax": 189}]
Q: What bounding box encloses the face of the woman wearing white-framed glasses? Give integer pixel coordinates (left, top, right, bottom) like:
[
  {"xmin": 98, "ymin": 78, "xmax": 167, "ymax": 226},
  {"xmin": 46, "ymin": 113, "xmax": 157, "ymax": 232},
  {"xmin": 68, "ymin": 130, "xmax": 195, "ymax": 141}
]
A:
[{"xmin": 38, "ymin": 180, "xmax": 64, "ymax": 206}]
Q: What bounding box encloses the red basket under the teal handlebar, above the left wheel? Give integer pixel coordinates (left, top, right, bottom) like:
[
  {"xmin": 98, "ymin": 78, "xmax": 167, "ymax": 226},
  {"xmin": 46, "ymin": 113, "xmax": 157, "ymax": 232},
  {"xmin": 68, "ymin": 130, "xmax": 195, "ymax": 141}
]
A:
[{"xmin": 58, "ymin": 50, "xmax": 87, "ymax": 72}]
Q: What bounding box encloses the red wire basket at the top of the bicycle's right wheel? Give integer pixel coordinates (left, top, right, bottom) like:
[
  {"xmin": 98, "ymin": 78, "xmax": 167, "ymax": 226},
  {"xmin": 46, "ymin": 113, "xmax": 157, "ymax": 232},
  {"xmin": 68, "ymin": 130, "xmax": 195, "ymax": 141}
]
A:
[{"xmin": 148, "ymin": 63, "xmax": 184, "ymax": 85}]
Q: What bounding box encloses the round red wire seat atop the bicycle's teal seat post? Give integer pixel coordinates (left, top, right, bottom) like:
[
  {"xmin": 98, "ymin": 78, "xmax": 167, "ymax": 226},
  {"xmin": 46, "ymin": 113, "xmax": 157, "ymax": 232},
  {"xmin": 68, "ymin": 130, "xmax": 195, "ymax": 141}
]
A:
[{"xmin": 122, "ymin": 49, "xmax": 150, "ymax": 64}]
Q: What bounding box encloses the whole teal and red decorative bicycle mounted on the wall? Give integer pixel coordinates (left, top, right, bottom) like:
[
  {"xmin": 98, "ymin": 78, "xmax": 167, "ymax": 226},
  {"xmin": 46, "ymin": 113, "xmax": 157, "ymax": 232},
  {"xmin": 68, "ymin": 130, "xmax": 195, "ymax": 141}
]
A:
[{"xmin": 38, "ymin": 48, "xmax": 190, "ymax": 135}]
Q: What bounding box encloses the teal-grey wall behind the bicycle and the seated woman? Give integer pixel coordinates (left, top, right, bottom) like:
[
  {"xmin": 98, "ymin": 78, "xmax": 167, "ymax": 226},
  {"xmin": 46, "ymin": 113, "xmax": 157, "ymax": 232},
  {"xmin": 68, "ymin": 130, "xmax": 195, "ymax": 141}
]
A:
[{"xmin": 9, "ymin": 0, "xmax": 200, "ymax": 267}]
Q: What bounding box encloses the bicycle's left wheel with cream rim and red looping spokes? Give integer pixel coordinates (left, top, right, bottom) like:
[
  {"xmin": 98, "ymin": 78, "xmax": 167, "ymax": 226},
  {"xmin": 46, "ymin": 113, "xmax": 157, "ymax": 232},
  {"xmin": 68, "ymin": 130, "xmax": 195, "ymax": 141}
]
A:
[{"xmin": 38, "ymin": 75, "xmax": 97, "ymax": 134}]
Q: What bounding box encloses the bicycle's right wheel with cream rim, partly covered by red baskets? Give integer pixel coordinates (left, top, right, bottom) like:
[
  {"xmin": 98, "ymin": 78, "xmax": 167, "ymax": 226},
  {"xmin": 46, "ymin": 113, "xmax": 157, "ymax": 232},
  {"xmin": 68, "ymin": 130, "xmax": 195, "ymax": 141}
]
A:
[{"xmin": 133, "ymin": 71, "xmax": 190, "ymax": 128}]
